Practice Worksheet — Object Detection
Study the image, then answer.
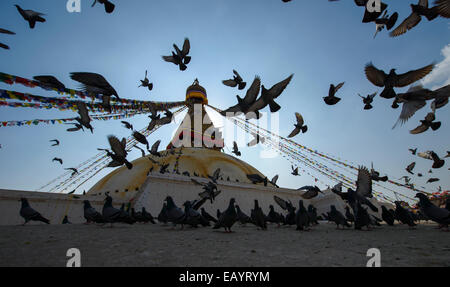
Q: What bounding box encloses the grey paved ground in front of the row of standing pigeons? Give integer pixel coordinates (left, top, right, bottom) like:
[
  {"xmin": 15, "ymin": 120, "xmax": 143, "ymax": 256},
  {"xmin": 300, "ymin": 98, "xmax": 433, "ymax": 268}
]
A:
[{"xmin": 0, "ymin": 222, "xmax": 450, "ymax": 267}]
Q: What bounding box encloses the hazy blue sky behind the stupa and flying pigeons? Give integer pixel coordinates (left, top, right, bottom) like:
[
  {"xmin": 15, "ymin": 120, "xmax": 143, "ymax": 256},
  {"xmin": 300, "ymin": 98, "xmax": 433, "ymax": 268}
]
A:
[{"xmin": 0, "ymin": 0, "xmax": 450, "ymax": 202}]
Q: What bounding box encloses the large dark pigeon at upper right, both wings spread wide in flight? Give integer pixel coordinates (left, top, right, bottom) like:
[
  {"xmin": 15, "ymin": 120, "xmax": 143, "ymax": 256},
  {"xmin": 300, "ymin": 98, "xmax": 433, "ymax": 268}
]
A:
[{"xmin": 365, "ymin": 63, "xmax": 434, "ymax": 99}]
